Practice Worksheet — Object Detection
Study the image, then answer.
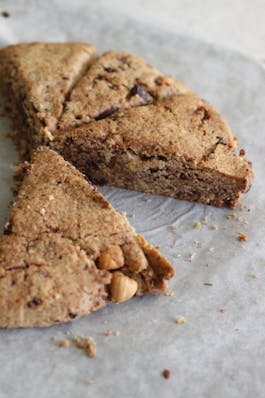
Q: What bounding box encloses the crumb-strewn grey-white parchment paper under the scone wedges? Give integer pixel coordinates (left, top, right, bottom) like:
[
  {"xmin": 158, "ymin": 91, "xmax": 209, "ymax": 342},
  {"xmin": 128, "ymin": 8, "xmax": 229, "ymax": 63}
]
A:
[{"xmin": 0, "ymin": 0, "xmax": 265, "ymax": 398}]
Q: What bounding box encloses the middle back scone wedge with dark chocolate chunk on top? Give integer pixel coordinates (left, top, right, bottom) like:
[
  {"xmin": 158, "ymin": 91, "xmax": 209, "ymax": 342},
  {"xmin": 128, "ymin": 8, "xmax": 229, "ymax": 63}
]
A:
[{"xmin": 58, "ymin": 51, "xmax": 191, "ymax": 130}]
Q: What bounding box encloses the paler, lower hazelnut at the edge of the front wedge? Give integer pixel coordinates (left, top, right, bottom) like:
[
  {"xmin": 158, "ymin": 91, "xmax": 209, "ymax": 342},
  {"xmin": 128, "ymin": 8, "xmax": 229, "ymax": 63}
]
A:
[{"xmin": 110, "ymin": 271, "xmax": 138, "ymax": 303}]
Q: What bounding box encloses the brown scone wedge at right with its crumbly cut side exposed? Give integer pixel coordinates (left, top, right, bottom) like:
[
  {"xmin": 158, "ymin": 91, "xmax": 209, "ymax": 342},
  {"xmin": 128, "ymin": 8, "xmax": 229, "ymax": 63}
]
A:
[{"xmin": 53, "ymin": 93, "xmax": 253, "ymax": 208}]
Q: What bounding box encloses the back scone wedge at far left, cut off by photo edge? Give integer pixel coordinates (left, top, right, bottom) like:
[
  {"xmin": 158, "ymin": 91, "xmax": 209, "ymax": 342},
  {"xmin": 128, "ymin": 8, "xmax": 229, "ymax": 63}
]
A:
[{"xmin": 0, "ymin": 42, "xmax": 96, "ymax": 154}]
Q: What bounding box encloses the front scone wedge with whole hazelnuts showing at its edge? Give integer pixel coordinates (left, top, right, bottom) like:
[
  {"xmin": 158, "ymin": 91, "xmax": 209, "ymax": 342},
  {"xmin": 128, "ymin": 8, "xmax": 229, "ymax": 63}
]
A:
[{"xmin": 0, "ymin": 149, "xmax": 174, "ymax": 328}]
